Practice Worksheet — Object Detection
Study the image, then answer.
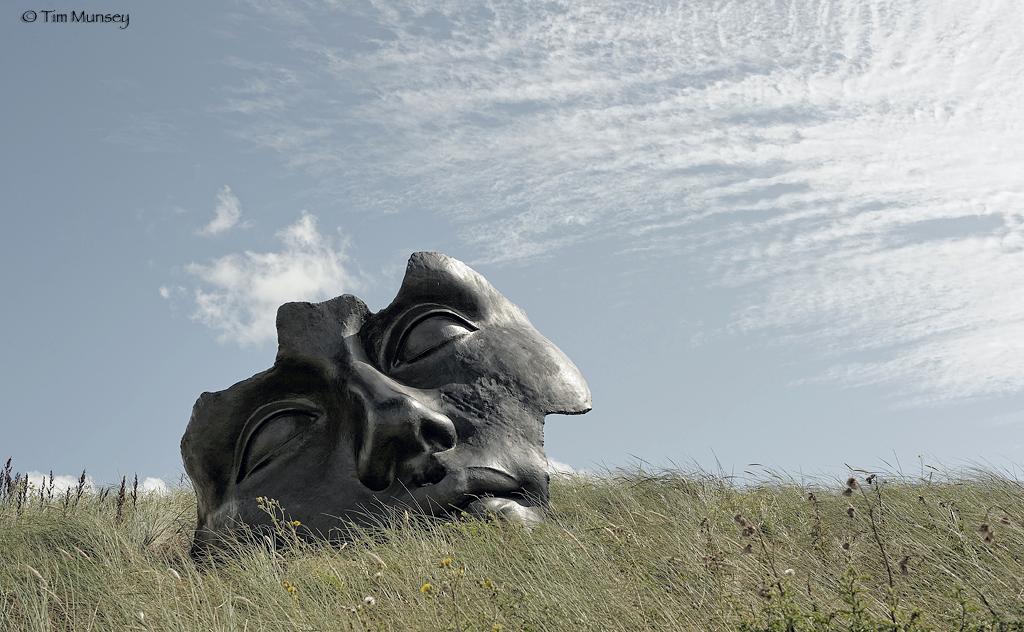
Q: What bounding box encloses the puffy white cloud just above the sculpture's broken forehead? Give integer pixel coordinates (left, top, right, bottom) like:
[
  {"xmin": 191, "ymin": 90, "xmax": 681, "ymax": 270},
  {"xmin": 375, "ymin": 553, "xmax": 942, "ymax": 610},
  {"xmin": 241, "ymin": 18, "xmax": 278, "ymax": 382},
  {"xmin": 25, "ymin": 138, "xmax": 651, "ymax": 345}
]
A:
[{"xmin": 185, "ymin": 213, "xmax": 358, "ymax": 345}]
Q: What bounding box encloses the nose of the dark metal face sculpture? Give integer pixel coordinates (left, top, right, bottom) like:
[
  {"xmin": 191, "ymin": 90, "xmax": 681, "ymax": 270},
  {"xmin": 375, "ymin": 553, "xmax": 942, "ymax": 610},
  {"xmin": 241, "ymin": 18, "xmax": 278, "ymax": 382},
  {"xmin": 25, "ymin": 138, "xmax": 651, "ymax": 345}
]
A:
[{"xmin": 349, "ymin": 363, "xmax": 456, "ymax": 491}]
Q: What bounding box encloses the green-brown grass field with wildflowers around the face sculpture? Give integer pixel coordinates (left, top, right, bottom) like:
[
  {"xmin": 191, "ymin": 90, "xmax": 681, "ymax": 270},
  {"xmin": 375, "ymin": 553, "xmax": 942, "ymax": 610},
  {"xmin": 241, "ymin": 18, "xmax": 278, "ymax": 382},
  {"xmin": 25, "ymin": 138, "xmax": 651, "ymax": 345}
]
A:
[{"xmin": 0, "ymin": 458, "xmax": 1024, "ymax": 631}]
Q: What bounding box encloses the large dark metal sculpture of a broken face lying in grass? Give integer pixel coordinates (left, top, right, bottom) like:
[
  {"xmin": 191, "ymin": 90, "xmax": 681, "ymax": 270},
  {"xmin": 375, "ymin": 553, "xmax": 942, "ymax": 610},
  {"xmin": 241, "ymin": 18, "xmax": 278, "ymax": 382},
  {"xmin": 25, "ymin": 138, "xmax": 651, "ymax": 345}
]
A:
[{"xmin": 181, "ymin": 252, "xmax": 591, "ymax": 547}]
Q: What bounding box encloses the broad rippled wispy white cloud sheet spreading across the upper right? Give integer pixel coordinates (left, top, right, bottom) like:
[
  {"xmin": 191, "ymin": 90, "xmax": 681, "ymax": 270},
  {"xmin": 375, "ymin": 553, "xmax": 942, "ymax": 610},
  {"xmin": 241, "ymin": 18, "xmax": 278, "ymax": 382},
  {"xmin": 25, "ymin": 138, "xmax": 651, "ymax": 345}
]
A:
[{"xmin": 220, "ymin": 0, "xmax": 1024, "ymax": 404}]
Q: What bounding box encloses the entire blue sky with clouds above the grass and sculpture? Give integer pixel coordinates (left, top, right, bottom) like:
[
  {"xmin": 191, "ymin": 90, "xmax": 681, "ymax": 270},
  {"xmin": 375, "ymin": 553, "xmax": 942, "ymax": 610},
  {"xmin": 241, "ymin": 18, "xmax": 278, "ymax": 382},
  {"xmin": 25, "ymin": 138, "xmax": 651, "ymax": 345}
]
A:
[{"xmin": 0, "ymin": 0, "xmax": 1024, "ymax": 481}]
